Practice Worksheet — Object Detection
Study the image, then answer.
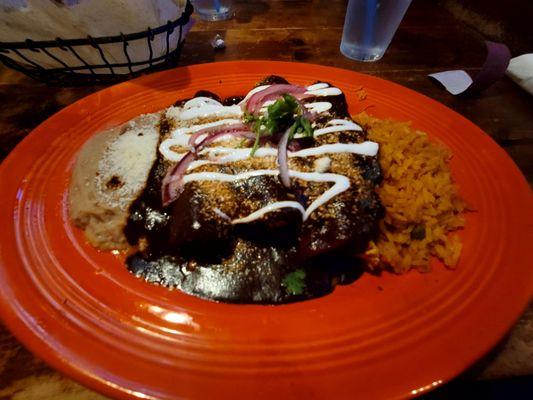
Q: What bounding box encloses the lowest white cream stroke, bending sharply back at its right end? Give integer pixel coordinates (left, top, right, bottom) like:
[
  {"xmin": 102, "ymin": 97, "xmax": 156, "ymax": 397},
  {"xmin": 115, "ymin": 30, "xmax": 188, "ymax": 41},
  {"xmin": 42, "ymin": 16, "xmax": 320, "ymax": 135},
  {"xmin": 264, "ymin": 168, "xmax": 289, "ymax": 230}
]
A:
[{"xmin": 183, "ymin": 169, "xmax": 350, "ymax": 224}]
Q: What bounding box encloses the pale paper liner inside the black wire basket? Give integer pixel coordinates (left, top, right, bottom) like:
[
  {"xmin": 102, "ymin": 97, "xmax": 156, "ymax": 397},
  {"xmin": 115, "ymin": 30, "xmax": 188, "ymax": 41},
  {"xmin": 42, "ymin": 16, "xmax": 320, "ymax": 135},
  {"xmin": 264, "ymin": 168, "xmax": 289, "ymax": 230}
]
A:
[{"xmin": 0, "ymin": 0, "xmax": 190, "ymax": 73}]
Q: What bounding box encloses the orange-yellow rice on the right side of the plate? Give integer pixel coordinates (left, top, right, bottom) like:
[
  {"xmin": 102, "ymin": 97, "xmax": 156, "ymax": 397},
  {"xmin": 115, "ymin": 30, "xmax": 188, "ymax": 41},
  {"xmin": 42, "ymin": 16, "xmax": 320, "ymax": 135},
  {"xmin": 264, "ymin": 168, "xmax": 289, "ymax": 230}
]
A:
[{"xmin": 355, "ymin": 112, "xmax": 466, "ymax": 273}]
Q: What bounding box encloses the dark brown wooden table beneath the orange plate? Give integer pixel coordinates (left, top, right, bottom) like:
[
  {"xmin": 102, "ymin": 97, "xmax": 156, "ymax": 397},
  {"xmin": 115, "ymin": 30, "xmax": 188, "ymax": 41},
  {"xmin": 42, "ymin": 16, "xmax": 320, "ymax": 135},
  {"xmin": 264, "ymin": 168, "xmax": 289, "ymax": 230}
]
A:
[{"xmin": 0, "ymin": 0, "xmax": 533, "ymax": 399}]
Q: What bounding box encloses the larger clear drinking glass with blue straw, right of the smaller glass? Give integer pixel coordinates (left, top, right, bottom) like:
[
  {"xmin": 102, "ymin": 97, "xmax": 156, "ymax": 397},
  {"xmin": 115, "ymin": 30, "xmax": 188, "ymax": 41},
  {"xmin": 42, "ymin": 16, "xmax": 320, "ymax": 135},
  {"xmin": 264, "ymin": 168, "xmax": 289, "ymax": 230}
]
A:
[{"xmin": 341, "ymin": 0, "xmax": 411, "ymax": 61}]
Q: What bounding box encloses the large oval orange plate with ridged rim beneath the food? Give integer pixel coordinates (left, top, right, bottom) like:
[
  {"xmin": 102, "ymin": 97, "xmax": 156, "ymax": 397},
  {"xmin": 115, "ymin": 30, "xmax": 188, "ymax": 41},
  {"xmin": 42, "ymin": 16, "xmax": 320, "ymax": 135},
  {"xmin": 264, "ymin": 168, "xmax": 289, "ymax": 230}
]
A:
[{"xmin": 0, "ymin": 61, "xmax": 533, "ymax": 399}]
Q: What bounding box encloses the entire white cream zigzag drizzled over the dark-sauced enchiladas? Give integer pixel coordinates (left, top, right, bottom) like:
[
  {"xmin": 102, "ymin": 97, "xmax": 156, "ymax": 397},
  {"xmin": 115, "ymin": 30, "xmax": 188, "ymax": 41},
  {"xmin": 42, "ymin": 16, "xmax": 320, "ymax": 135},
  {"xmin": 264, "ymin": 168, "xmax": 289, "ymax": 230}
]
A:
[{"xmin": 159, "ymin": 83, "xmax": 378, "ymax": 224}]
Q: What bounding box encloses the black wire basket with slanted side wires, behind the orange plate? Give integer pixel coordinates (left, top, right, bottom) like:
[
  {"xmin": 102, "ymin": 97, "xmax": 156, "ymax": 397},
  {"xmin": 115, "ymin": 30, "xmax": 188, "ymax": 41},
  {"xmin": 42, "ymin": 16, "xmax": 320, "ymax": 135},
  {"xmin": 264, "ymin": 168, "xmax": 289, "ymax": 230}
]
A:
[{"xmin": 0, "ymin": 0, "xmax": 193, "ymax": 86}]
